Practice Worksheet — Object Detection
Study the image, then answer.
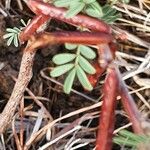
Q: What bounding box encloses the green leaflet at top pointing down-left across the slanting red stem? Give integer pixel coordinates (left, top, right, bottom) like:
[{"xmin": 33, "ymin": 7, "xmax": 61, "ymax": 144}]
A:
[{"xmin": 65, "ymin": 2, "xmax": 85, "ymax": 18}]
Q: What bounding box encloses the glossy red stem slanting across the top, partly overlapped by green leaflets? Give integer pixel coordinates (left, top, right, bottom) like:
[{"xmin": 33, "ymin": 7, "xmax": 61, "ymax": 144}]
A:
[{"xmin": 24, "ymin": 0, "xmax": 111, "ymax": 33}]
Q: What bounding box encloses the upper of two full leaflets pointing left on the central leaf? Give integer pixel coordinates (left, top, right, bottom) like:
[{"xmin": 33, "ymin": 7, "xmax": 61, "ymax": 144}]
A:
[{"xmin": 52, "ymin": 53, "xmax": 76, "ymax": 65}]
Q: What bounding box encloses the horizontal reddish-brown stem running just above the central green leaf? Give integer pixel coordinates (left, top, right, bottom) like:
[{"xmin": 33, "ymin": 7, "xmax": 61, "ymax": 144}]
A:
[{"xmin": 27, "ymin": 32, "xmax": 113, "ymax": 49}]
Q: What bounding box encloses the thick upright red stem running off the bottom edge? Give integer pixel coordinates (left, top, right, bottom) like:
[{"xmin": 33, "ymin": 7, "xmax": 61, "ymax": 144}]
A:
[{"xmin": 96, "ymin": 68, "xmax": 118, "ymax": 150}]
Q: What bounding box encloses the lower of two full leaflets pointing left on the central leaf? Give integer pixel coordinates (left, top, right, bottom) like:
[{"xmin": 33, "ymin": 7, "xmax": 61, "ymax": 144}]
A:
[{"xmin": 50, "ymin": 64, "xmax": 74, "ymax": 77}]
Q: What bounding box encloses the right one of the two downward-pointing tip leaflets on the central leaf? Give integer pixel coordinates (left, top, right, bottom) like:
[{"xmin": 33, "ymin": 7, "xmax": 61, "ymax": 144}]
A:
[{"xmin": 77, "ymin": 66, "xmax": 93, "ymax": 91}]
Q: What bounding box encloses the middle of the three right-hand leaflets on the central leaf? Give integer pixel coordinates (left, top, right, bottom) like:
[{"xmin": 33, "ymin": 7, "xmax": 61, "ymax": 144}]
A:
[{"xmin": 78, "ymin": 56, "xmax": 96, "ymax": 74}]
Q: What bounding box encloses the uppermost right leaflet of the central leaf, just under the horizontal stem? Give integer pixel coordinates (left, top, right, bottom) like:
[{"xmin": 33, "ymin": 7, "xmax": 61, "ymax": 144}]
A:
[{"xmin": 78, "ymin": 45, "xmax": 96, "ymax": 59}]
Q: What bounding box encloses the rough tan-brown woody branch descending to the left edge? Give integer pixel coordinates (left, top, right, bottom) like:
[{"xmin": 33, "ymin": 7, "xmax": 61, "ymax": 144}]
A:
[{"xmin": 0, "ymin": 42, "xmax": 36, "ymax": 134}]
